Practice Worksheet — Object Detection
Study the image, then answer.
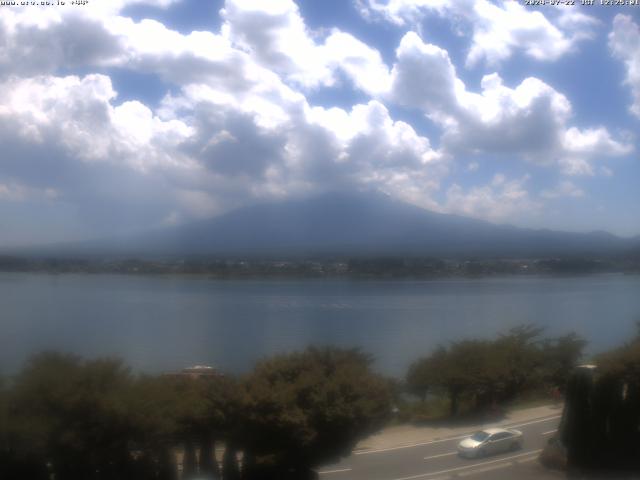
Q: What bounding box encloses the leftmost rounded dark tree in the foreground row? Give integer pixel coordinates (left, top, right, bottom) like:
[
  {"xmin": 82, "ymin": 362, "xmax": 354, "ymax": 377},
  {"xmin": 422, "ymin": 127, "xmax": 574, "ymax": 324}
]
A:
[{"xmin": 9, "ymin": 353, "xmax": 137, "ymax": 480}]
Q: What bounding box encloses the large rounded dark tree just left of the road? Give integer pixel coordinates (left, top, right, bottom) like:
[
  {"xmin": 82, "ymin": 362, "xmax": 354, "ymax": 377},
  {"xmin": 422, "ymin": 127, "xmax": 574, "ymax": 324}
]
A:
[{"xmin": 242, "ymin": 348, "xmax": 391, "ymax": 479}]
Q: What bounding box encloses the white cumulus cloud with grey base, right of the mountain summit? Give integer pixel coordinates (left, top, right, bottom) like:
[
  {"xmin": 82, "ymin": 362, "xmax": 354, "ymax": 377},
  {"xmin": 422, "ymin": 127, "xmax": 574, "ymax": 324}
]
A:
[{"xmin": 389, "ymin": 32, "xmax": 633, "ymax": 175}]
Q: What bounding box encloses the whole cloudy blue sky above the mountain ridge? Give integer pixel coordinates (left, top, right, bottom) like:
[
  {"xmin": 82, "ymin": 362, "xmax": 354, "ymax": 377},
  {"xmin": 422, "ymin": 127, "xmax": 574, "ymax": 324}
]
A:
[{"xmin": 0, "ymin": 0, "xmax": 640, "ymax": 246}]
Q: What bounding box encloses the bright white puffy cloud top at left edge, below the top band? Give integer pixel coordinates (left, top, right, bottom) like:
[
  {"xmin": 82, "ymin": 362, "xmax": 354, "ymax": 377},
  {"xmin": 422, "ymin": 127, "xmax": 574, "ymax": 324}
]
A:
[{"xmin": 0, "ymin": 75, "xmax": 190, "ymax": 170}]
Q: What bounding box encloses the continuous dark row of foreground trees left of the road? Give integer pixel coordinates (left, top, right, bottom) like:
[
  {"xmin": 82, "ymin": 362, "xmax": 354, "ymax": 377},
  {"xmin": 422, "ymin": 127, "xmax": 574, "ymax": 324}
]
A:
[{"xmin": 0, "ymin": 348, "xmax": 391, "ymax": 480}]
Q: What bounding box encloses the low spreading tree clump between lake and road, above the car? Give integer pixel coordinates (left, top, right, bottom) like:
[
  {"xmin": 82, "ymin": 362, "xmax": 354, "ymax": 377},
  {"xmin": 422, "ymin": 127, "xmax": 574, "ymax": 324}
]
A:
[{"xmin": 406, "ymin": 325, "xmax": 585, "ymax": 415}]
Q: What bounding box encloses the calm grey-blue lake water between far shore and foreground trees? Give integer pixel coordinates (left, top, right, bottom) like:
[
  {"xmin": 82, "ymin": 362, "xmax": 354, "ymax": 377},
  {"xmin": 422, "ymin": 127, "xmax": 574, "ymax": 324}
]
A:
[{"xmin": 0, "ymin": 273, "xmax": 640, "ymax": 375}]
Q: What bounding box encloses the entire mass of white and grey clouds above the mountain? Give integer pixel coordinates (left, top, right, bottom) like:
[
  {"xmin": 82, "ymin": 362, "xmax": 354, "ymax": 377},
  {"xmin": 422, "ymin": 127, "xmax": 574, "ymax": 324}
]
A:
[{"xmin": 0, "ymin": 0, "xmax": 631, "ymax": 240}]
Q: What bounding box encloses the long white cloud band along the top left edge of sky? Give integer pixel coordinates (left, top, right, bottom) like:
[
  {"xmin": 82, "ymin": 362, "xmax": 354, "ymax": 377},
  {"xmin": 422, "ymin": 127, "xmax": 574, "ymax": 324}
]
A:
[{"xmin": 0, "ymin": 0, "xmax": 389, "ymax": 94}]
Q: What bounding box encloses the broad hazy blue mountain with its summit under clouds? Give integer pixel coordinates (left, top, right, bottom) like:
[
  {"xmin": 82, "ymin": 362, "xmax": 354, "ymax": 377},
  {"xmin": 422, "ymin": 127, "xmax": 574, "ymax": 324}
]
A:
[{"xmin": 53, "ymin": 192, "xmax": 640, "ymax": 256}]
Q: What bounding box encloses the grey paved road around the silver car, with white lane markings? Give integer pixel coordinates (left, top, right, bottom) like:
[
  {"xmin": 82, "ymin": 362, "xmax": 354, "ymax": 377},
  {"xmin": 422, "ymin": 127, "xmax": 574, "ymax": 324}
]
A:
[{"xmin": 319, "ymin": 415, "xmax": 560, "ymax": 480}]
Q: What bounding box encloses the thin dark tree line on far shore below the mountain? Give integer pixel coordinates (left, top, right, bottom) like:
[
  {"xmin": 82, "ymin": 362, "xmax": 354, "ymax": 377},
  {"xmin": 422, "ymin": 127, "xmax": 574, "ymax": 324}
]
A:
[{"xmin": 0, "ymin": 253, "xmax": 640, "ymax": 279}]
